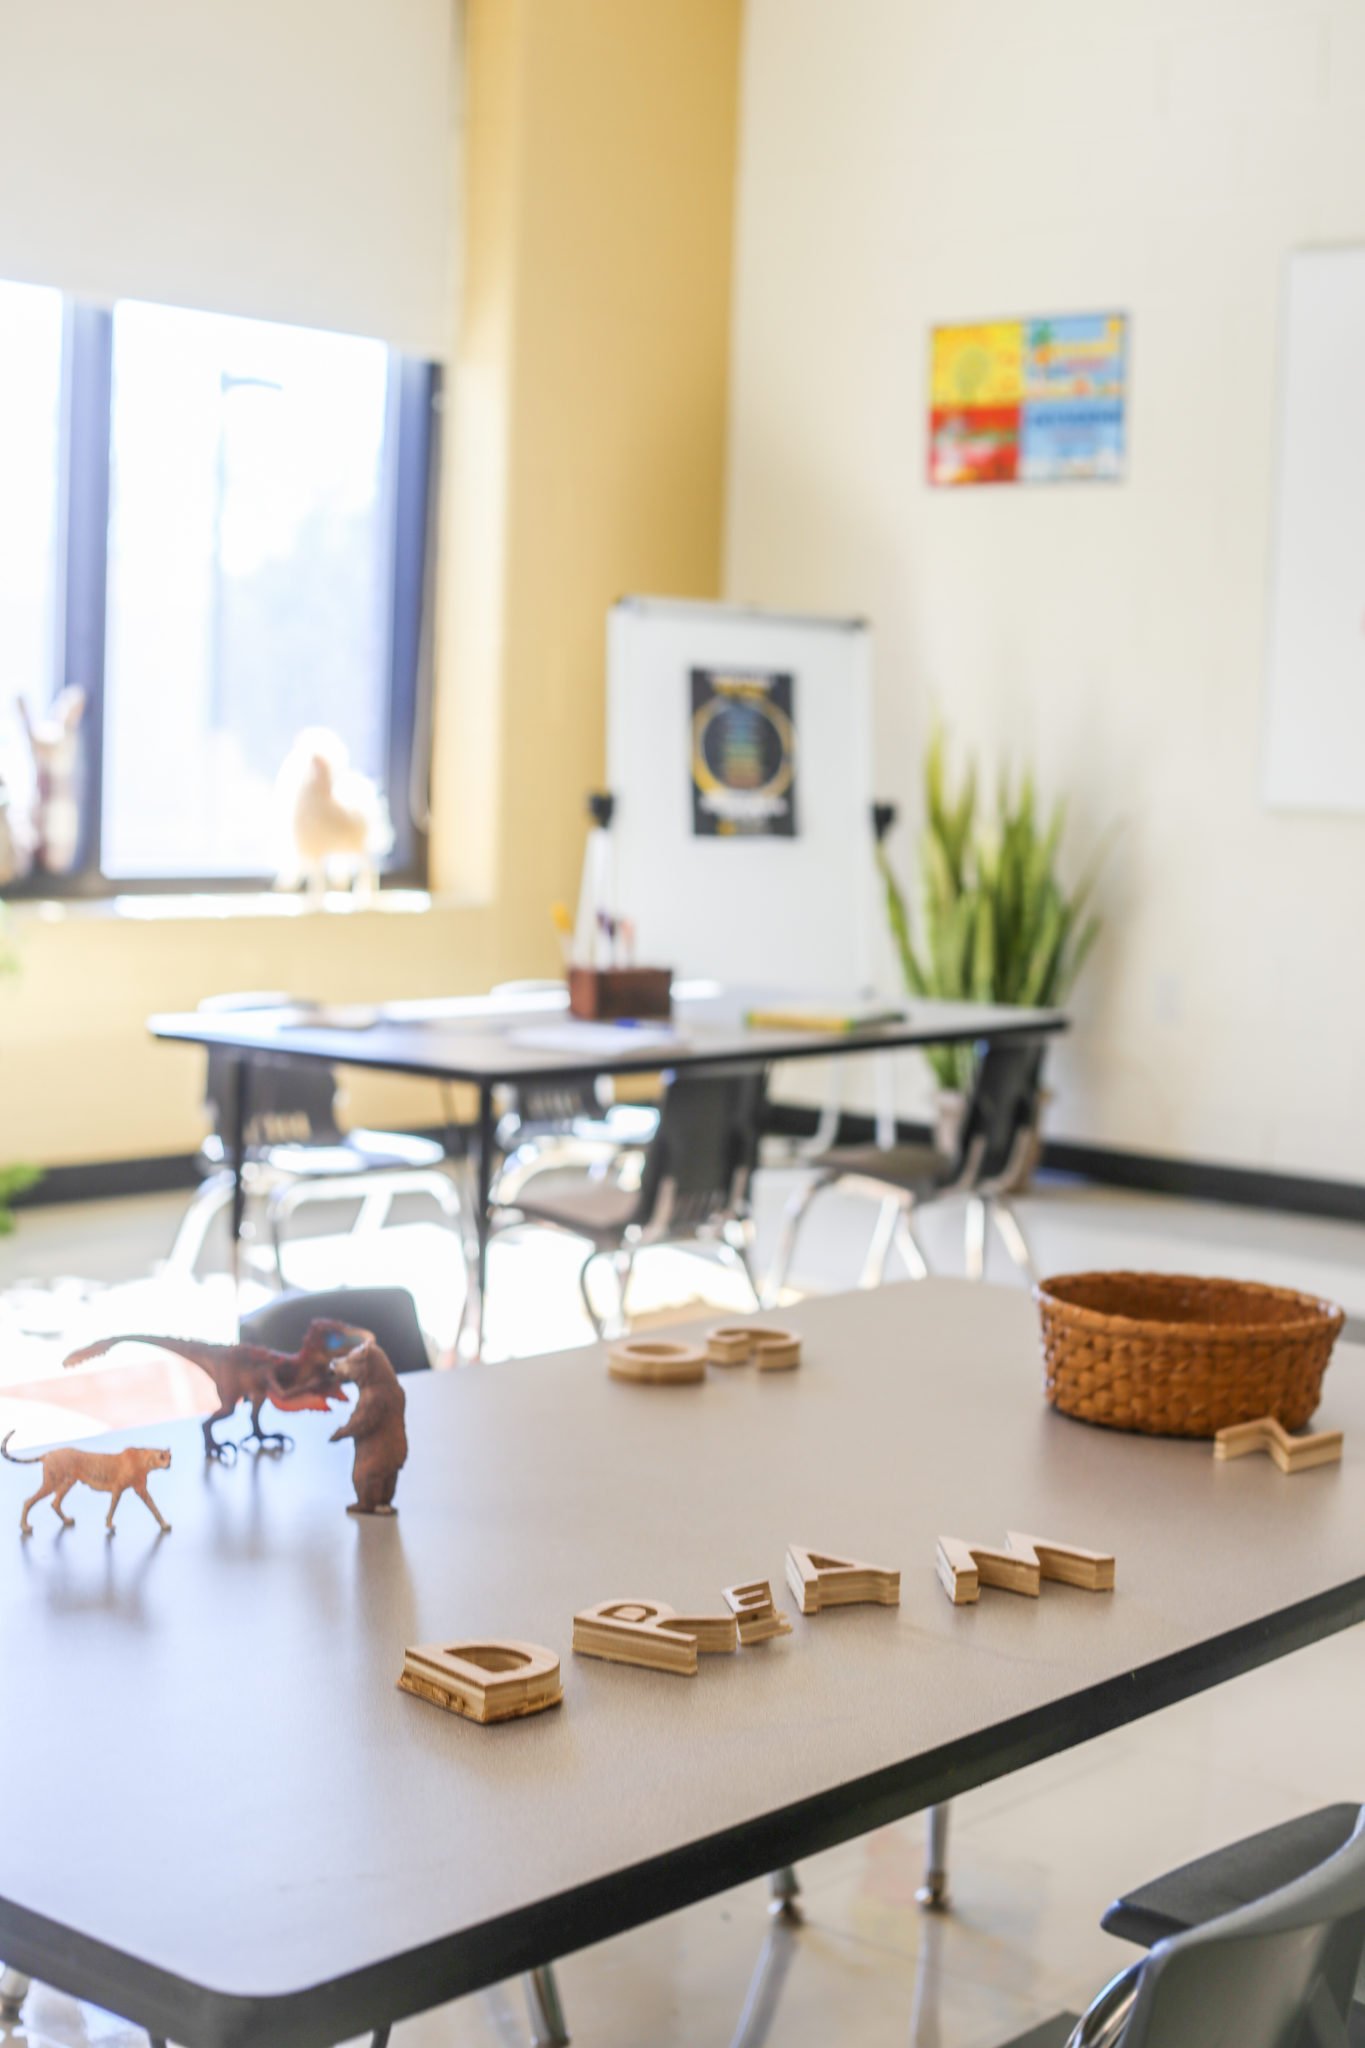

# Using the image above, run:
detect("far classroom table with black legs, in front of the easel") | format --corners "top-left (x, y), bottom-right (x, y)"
top-left (149, 983), bottom-right (1068, 1358)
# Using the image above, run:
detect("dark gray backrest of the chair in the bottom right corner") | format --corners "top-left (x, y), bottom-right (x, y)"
top-left (1124, 1815), bottom-right (1365, 2048)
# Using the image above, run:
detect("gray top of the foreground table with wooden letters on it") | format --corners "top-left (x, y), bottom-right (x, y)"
top-left (0, 1280), bottom-right (1365, 2048)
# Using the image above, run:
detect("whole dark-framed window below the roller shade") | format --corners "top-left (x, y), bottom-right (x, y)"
top-left (0, 285), bottom-right (436, 893)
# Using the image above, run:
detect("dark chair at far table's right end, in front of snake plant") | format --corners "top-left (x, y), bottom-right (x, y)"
top-left (767, 1038), bottom-right (1044, 1305)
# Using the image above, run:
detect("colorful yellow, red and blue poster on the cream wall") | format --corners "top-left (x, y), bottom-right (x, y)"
top-left (929, 313), bottom-right (1128, 483)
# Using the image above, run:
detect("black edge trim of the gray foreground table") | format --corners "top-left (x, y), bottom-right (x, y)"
top-left (0, 1577), bottom-right (1365, 2048)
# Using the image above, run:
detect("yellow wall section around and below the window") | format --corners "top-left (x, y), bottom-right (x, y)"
top-left (0, 0), bottom-right (741, 1165)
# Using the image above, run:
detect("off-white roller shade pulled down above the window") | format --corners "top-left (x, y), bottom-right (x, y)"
top-left (0, 0), bottom-right (456, 356)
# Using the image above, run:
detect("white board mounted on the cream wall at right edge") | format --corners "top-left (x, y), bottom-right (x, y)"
top-left (1265, 248), bottom-right (1365, 811)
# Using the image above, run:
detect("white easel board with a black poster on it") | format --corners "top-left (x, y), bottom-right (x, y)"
top-left (608, 598), bottom-right (876, 995)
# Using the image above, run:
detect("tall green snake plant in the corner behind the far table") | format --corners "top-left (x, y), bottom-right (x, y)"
top-left (876, 727), bottom-right (1105, 1153)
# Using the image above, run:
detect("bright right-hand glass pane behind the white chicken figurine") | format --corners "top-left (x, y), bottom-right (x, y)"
top-left (103, 297), bottom-right (393, 877)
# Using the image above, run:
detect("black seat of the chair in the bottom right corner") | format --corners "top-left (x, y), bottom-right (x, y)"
top-left (1101, 1804), bottom-right (1361, 1948)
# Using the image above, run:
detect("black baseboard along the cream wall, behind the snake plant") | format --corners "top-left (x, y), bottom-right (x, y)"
top-left (767, 1102), bottom-right (1365, 1223)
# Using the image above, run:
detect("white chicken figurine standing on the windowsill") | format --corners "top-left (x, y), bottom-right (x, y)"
top-left (276, 725), bottom-right (393, 895)
